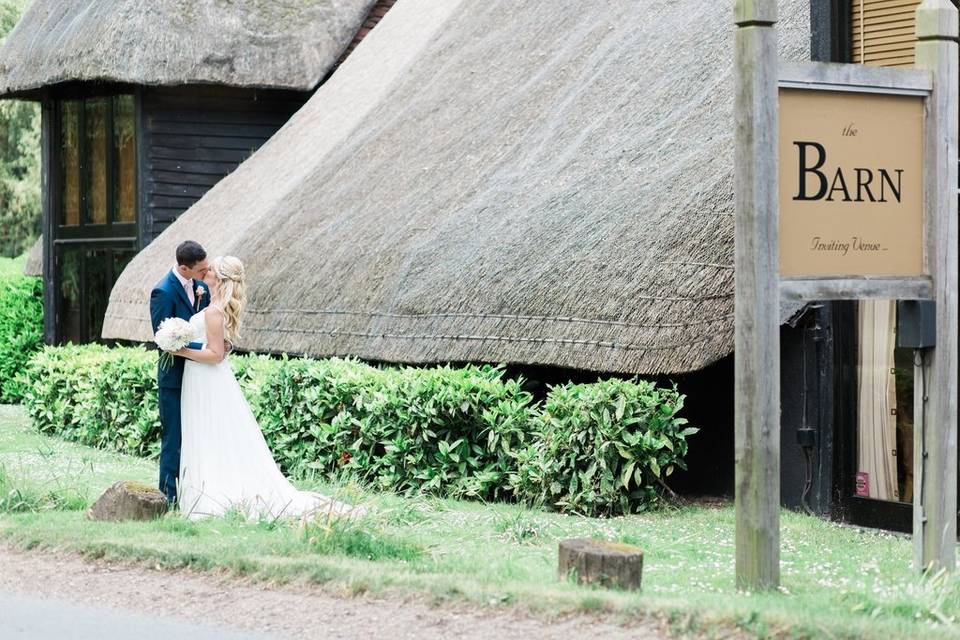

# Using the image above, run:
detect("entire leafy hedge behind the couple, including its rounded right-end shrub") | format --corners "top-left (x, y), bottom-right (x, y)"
top-left (25, 345), bottom-right (695, 515)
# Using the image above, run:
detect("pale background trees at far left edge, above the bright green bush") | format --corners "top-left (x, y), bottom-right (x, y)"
top-left (0, 0), bottom-right (40, 257)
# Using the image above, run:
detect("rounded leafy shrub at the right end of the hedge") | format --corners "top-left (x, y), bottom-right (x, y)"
top-left (512, 380), bottom-right (697, 516)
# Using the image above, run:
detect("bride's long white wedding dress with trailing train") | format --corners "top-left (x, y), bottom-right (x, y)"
top-left (179, 311), bottom-right (363, 519)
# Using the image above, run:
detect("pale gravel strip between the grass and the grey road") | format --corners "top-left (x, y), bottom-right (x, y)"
top-left (0, 546), bottom-right (667, 640)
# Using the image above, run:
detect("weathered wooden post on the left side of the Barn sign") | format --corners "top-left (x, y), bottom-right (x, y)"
top-left (734, 0), bottom-right (780, 590)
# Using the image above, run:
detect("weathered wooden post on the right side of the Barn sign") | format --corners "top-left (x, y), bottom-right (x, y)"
top-left (913, 0), bottom-right (958, 571)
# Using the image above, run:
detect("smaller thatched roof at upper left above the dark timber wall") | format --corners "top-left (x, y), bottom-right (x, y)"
top-left (0, 0), bottom-right (374, 96)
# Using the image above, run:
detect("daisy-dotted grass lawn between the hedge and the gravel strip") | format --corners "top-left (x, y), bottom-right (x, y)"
top-left (0, 406), bottom-right (960, 640)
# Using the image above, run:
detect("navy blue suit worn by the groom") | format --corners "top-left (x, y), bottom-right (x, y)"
top-left (150, 269), bottom-right (210, 504)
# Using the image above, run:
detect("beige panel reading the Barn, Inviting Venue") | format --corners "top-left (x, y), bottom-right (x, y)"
top-left (780, 89), bottom-right (923, 278)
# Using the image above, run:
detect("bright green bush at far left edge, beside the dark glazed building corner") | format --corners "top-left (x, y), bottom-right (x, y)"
top-left (0, 276), bottom-right (43, 403)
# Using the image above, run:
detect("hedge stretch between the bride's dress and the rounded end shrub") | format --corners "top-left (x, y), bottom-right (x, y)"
top-left (253, 359), bottom-right (531, 499)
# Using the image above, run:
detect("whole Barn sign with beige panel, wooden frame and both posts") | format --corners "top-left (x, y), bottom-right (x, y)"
top-left (734, 0), bottom-right (958, 589)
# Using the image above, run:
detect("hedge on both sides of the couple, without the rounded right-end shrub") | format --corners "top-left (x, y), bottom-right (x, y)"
top-left (25, 345), bottom-right (530, 498)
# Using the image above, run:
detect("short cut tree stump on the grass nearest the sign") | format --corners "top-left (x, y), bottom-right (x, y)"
top-left (558, 538), bottom-right (643, 589)
